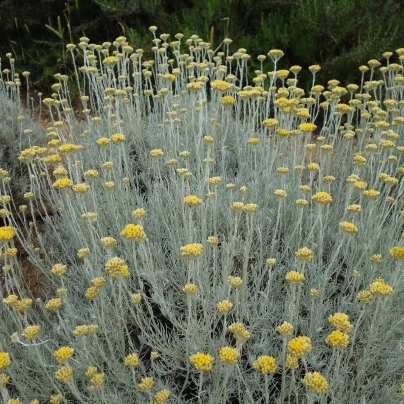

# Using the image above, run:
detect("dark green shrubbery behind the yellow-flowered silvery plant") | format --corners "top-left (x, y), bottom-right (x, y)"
top-left (0, 0), bottom-right (404, 90)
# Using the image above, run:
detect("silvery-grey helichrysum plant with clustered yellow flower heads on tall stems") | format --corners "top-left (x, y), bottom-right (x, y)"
top-left (0, 30), bottom-right (404, 404)
